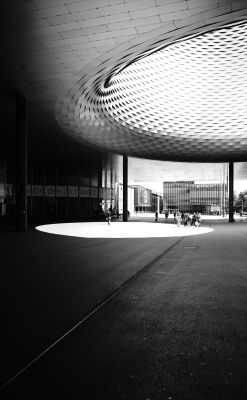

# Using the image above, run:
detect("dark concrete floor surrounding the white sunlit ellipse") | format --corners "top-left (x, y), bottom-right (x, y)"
top-left (0, 219), bottom-right (247, 400)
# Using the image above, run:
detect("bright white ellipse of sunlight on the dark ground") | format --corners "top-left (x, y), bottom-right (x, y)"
top-left (36, 221), bottom-right (213, 238)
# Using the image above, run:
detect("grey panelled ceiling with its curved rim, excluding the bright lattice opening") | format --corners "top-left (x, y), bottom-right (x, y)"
top-left (0, 0), bottom-right (247, 161)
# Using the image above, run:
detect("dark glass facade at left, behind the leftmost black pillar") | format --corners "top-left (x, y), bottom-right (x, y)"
top-left (0, 152), bottom-right (122, 222)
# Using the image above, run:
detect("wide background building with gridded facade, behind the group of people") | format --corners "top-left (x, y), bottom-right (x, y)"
top-left (163, 181), bottom-right (228, 215)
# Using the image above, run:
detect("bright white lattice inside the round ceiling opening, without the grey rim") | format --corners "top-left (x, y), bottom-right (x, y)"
top-left (102, 22), bottom-right (247, 142)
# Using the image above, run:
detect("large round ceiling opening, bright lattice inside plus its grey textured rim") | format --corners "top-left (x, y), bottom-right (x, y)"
top-left (57, 10), bottom-right (247, 161)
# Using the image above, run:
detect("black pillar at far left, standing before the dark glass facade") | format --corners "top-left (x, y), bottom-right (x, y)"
top-left (16, 97), bottom-right (27, 232)
